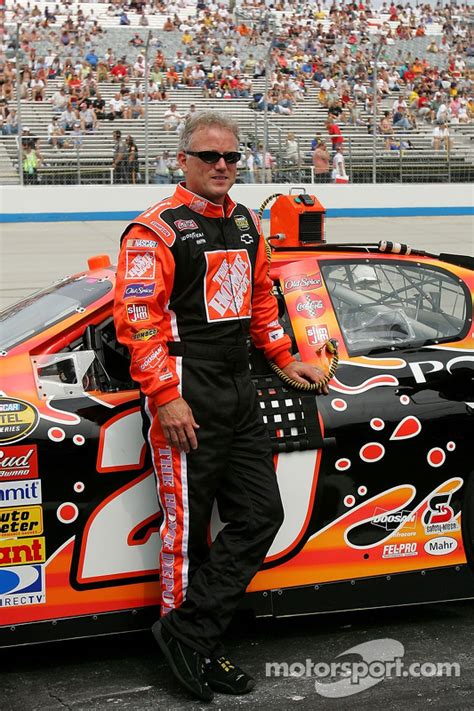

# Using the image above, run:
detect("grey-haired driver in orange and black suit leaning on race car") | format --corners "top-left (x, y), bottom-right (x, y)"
top-left (114, 112), bottom-right (323, 701)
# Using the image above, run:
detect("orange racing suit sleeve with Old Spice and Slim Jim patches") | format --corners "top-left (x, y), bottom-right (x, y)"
top-left (114, 225), bottom-right (180, 405)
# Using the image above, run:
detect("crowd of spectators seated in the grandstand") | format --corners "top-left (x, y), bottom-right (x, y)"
top-left (0, 0), bottom-right (474, 180)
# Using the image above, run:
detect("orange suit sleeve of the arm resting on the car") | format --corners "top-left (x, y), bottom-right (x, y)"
top-left (250, 229), bottom-right (295, 368)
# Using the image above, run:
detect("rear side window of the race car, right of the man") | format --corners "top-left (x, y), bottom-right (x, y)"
top-left (321, 259), bottom-right (468, 355)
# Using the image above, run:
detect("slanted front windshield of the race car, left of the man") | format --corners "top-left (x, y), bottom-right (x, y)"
top-left (0, 276), bottom-right (112, 351)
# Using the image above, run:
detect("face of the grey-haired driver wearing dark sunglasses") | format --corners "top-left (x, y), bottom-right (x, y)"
top-left (177, 126), bottom-right (238, 205)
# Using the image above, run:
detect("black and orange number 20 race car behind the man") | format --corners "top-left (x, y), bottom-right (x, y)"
top-left (0, 195), bottom-right (474, 646)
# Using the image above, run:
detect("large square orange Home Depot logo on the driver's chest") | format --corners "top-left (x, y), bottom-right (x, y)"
top-left (204, 249), bottom-right (251, 323)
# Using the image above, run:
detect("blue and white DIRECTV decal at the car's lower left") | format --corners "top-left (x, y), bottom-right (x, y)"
top-left (0, 565), bottom-right (46, 607)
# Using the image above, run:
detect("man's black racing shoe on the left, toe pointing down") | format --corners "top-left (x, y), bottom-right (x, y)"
top-left (151, 622), bottom-right (214, 701)
